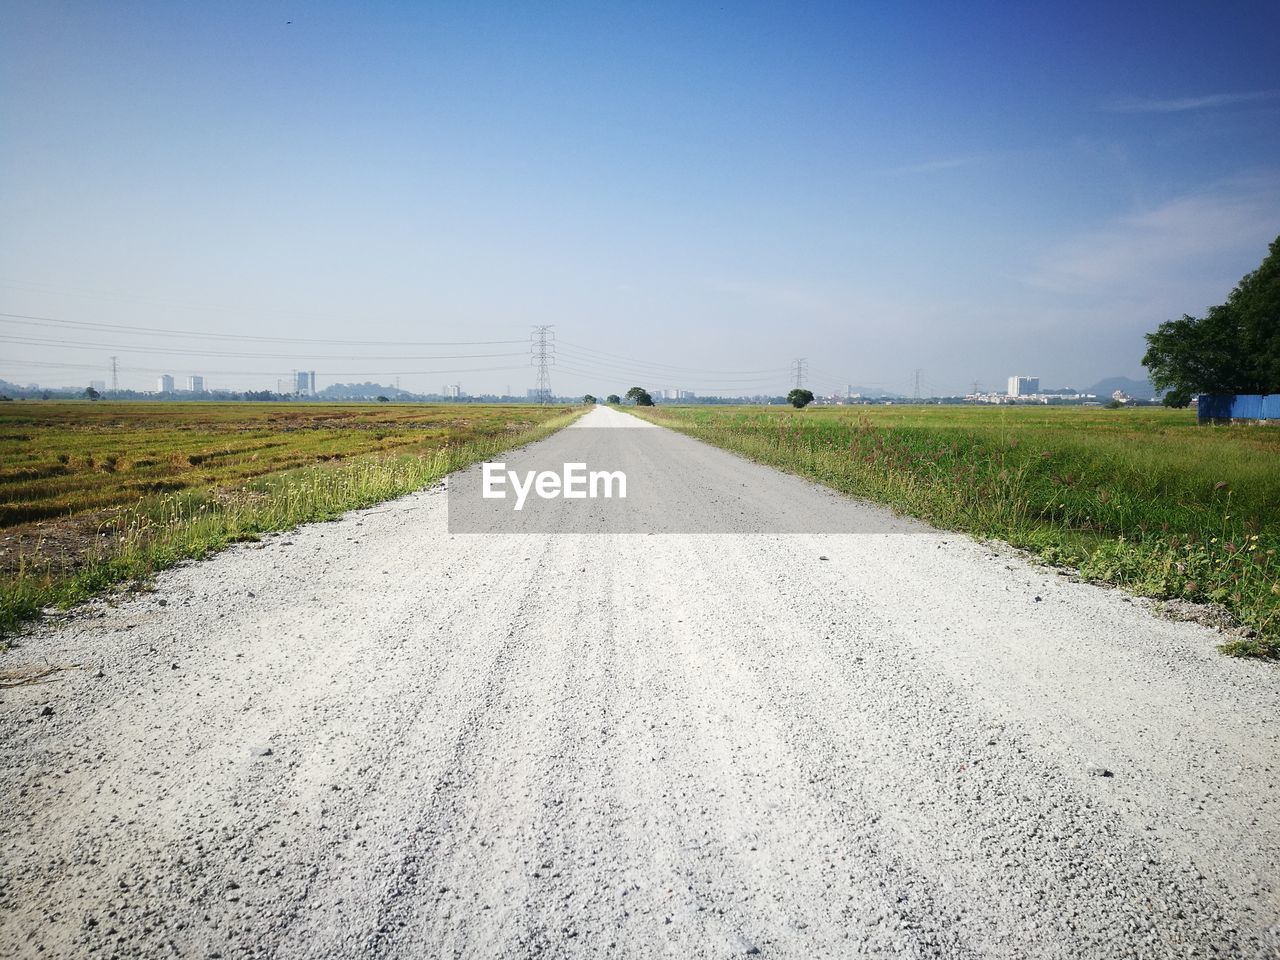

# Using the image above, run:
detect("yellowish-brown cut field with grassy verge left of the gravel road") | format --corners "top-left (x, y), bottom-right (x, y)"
top-left (0, 402), bottom-right (582, 643)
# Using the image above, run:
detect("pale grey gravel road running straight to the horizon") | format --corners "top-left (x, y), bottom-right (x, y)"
top-left (0, 408), bottom-right (1280, 957)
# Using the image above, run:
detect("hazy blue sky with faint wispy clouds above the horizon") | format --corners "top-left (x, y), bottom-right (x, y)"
top-left (0, 0), bottom-right (1280, 393)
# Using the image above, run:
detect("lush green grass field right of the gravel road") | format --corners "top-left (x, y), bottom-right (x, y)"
top-left (632, 406), bottom-right (1280, 657)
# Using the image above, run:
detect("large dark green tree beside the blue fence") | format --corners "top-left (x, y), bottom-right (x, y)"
top-left (1142, 237), bottom-right (1280, 406)
